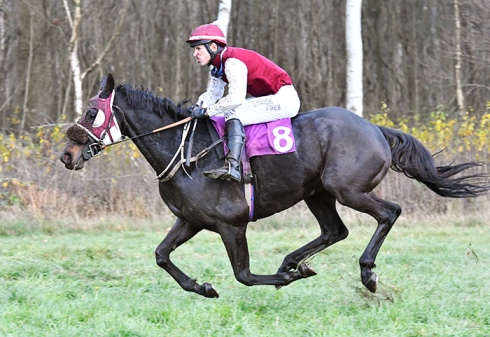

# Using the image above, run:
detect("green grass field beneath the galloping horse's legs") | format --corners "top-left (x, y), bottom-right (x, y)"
top-left (0, 213), bottom-right (490, 337)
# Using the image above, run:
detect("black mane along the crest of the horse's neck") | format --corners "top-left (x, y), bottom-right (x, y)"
top-left (116, 83), bottom-right (189, 119)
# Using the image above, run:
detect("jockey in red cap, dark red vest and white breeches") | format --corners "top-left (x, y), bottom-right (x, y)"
top-left (186, 24), bottom-right (300, 181)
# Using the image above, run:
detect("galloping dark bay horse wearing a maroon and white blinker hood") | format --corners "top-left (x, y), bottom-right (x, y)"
top-left (60, 74), bottom-right (490, 297)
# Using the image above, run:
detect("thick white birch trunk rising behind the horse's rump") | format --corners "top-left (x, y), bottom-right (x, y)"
top-left (345, 0), bottom-right (363, 117)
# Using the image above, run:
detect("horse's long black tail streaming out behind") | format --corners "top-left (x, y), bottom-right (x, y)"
top-left (377, 125), bottom-right (490, 198)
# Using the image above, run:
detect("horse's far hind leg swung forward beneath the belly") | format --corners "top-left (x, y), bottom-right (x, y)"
top-left (277, 190), bottom-right (349, 275)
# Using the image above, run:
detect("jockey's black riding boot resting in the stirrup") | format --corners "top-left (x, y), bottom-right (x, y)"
top-left (204, 118), bottom-right (245, 181)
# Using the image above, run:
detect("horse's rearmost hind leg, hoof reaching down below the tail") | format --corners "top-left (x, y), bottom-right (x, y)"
top-left (339, 192), bottom-right (401, 293)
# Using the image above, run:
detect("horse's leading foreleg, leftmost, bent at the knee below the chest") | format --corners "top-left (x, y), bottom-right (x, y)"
top-left (155, 219), bottom-right (219, 297)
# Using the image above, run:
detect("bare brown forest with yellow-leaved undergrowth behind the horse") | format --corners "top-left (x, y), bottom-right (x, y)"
top-left (0, 0), bottom-right (490, 223)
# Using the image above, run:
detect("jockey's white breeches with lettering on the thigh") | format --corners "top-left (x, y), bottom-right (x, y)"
top-left (219, 85), bottom-right (300, 125)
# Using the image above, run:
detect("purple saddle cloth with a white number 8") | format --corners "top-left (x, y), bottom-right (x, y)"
top-left (211, 116), bottom-right (296, 160)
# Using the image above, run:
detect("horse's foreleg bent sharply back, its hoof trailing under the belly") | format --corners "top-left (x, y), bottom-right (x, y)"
top-left (219, 225), bottom-right (311, 286)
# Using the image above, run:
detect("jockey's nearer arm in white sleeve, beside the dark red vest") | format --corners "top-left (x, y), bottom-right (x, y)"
top-left (206, 58), bottom-right (248, 117)
